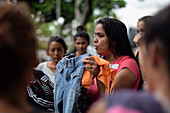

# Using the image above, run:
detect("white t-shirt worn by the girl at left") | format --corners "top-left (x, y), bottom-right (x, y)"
top-left (36, 62), bottom-right (55, 84)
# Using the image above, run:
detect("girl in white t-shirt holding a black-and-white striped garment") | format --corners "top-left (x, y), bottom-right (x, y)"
top-left (27, 36), bottom-right (67, 112)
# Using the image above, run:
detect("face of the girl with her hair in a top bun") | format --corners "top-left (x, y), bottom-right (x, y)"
top-left (75, 37), bottom-right (88, 55)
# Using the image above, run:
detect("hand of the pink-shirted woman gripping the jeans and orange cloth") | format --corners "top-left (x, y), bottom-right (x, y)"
top-left (82, 57), bottom-right (100, 77)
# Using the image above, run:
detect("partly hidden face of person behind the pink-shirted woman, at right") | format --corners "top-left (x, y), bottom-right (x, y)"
top-left (137, 20), bottom-right (145, 37)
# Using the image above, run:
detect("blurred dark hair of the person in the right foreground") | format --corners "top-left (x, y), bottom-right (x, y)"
top-left (144, 5), bottom-right (170, 73)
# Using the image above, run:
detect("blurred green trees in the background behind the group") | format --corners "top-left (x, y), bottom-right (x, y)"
top-left (17, 0), bottom-right (126, 52)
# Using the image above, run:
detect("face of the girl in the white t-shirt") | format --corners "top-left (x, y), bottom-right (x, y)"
top-left (48, 41), bottom-right (64, 64)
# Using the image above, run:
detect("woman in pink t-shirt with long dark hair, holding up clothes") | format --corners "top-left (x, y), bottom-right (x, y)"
top-left (82, 17), bottom-right (140, 101)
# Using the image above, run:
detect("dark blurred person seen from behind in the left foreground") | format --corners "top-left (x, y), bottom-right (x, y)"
top-left (0, 3), bottom-right (38, 113)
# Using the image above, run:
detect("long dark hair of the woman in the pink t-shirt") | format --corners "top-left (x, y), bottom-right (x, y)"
top-left (96, 17), bottom-right (135, 59)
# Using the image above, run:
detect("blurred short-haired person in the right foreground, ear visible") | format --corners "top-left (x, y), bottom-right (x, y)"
top-left (139, 5), bottom-right (170, 113)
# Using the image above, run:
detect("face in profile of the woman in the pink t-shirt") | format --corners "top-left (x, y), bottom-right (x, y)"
top-left (93, 24), bottom-right (111, 57)
